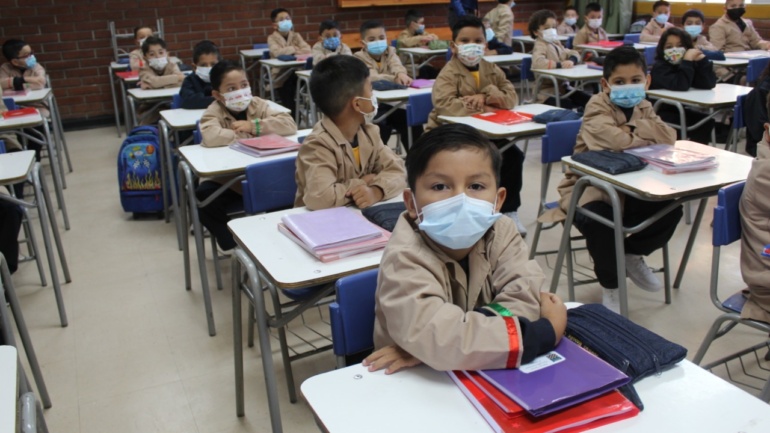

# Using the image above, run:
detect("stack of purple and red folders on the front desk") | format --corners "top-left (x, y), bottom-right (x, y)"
top-left (449, 338), bottom-right (639, 433)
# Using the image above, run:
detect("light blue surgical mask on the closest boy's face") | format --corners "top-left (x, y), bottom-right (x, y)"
top-left (412, 193), bottom-right (502, 250)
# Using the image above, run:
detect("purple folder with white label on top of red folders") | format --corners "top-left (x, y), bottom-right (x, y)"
top-left (479, 338), bottom-right (631, 416)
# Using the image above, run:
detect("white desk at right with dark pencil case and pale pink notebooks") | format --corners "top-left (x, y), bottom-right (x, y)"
top-left (551, 141), bottom-right (752, 317)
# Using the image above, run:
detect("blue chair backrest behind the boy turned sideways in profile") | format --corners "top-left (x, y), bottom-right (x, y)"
top-left (241, 157), bottom-right (297, 215)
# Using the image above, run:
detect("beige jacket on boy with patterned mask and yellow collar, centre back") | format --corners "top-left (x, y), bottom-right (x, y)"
top-left (425, 56), bottom-right (519, 131)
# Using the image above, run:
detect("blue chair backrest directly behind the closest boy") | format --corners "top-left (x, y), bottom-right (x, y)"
top-left (329, 269), bottom-right (379, 356)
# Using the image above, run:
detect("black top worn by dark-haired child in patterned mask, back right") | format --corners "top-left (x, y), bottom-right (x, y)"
top-left (650, 58), bottom-right (717, 92)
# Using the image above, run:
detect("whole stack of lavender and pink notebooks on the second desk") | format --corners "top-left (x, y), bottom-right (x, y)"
top-left (278, 207), bottom-right (390, 263)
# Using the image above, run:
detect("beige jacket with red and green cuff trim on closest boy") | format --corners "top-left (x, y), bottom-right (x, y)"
top-left (374, 213), bottom-right (545, 370)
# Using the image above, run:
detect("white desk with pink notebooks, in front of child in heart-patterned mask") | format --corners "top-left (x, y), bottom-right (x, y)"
top-left (177, 129), bottom-right (311, 336)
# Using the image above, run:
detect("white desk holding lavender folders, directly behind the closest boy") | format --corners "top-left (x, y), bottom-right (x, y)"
top-left (228, 199), bottom-right (398, 433)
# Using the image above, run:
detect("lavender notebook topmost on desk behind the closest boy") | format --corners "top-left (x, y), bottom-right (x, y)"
top-left (281, 207), bottom-right (382, 250)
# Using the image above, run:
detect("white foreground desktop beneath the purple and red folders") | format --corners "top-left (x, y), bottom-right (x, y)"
top-left (302, 360), bottom-right (770, 433)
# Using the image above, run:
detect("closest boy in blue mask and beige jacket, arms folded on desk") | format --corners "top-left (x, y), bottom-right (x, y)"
top-left (363, 123), bottom-right (567, 373)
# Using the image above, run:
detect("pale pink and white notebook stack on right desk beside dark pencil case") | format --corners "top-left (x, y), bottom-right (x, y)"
top-left (625, 144), bottom-right (719, 174)
